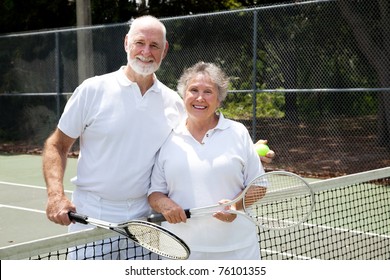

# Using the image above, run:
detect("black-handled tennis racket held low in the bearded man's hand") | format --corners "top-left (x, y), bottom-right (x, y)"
top-left (69, 212), bottom-right (190, 260)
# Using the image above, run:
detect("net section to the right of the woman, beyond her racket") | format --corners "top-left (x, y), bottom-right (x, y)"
top-left (259, 167), bottom-right (390, 260)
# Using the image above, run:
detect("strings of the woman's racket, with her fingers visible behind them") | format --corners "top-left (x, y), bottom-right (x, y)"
top-left (243, 174), bottom-right (313, 229)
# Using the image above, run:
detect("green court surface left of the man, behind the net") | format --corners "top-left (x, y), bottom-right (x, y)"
top-left (0, 155), bottom-right (77, 247)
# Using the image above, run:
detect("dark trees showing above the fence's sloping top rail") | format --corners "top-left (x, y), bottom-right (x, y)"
top-left (0, 0), bottom-right (280, 34)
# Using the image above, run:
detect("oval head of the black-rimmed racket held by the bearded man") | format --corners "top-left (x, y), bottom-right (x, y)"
top-left (123, 220), bottom-right (191, 260)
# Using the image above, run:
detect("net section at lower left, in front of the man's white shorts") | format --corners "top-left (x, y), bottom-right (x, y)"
top-left (0, 228), bottom-right (160, 260)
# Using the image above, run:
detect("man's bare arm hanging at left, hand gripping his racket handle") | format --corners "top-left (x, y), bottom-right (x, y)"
top-left (42, 128), bottom-right (76, 225)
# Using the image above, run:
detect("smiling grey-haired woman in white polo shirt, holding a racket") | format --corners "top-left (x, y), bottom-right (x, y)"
top-left (148, 62), bottom-right (264, 260)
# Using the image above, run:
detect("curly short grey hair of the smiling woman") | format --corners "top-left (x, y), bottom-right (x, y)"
top-left (177, 61), bottom-right (229, 103)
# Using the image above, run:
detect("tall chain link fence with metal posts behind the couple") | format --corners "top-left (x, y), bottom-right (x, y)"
top-left (0, 0), bottom-right (390, 177)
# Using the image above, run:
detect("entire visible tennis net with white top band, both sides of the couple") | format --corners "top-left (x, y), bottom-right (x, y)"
top-left (0, 167), bottom-right (390, 260)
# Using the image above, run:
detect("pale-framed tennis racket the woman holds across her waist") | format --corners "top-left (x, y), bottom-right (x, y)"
top-left (148, 171), bottom-right (315, 230)
